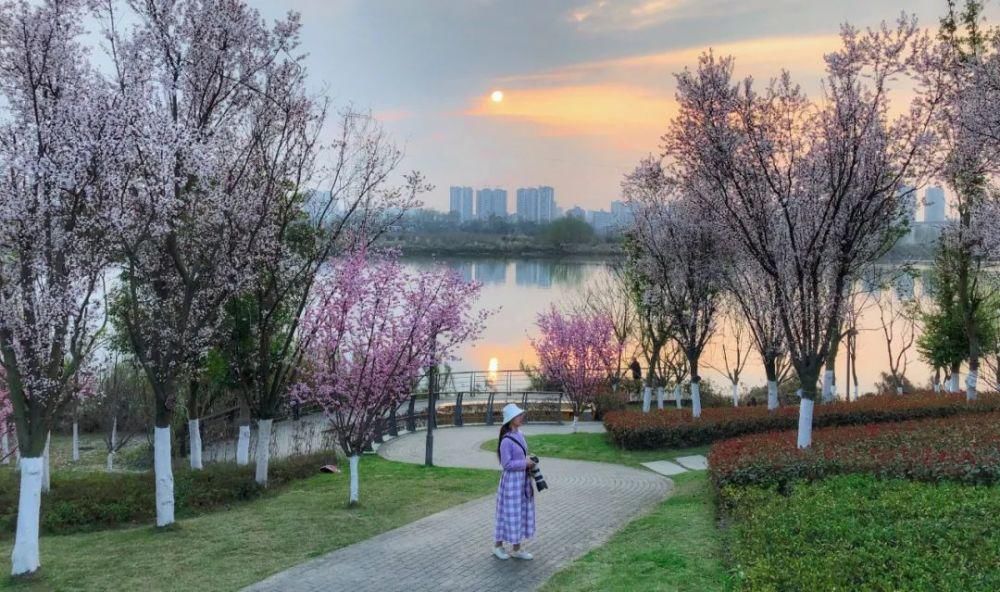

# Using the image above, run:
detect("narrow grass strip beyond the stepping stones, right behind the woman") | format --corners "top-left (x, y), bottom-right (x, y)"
top-left (483, 433), bottom-right (709, 467)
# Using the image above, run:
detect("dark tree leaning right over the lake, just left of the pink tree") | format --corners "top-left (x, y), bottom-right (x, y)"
top-left (221, 109), bottom-right (430, 485)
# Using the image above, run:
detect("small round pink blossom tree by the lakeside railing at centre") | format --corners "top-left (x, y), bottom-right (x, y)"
top-left (531, 307), bottom-right (622, 433)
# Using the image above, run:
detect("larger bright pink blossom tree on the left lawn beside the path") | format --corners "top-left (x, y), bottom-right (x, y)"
top-left (292, 251), bottom-right (486, 504)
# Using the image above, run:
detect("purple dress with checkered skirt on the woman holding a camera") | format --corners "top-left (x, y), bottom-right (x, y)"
top-left (493, 431), bottom-right (535, 545)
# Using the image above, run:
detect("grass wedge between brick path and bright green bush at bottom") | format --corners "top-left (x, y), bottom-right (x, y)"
top-left (542, 472), bottom-right (729, 592)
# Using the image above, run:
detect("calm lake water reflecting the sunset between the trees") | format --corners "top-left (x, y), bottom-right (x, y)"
top-left (406, 257), bottom-right (932, 393)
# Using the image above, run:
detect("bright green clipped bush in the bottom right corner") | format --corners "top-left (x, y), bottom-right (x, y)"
top-left (729, 475), bottom-right (1000, 591)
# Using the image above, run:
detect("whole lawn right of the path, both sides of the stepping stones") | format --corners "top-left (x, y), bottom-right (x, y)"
top-left (483, 433), bottom-right (730, 592)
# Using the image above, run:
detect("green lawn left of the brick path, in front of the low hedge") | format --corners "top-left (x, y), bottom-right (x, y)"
top-left (0, 456), bottom-right (497, 592)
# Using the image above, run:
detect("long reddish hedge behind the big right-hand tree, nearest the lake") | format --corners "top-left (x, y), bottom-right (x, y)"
top-left (604, 393), bottom-right (1000, 450)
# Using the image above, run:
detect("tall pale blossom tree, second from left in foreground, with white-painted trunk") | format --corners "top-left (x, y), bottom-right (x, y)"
top-left (100, 0), bottom-right (318, 526)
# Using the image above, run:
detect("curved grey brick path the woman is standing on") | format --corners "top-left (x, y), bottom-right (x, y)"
top-left (247, 424), bottom-right (673, 592)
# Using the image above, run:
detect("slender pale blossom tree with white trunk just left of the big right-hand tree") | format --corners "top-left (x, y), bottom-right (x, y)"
top-left (623, 159), bottom-right (729, 417)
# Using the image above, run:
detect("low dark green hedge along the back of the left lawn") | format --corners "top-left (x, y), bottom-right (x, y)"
top-left (0, 452), bottom-right (335, 534)
